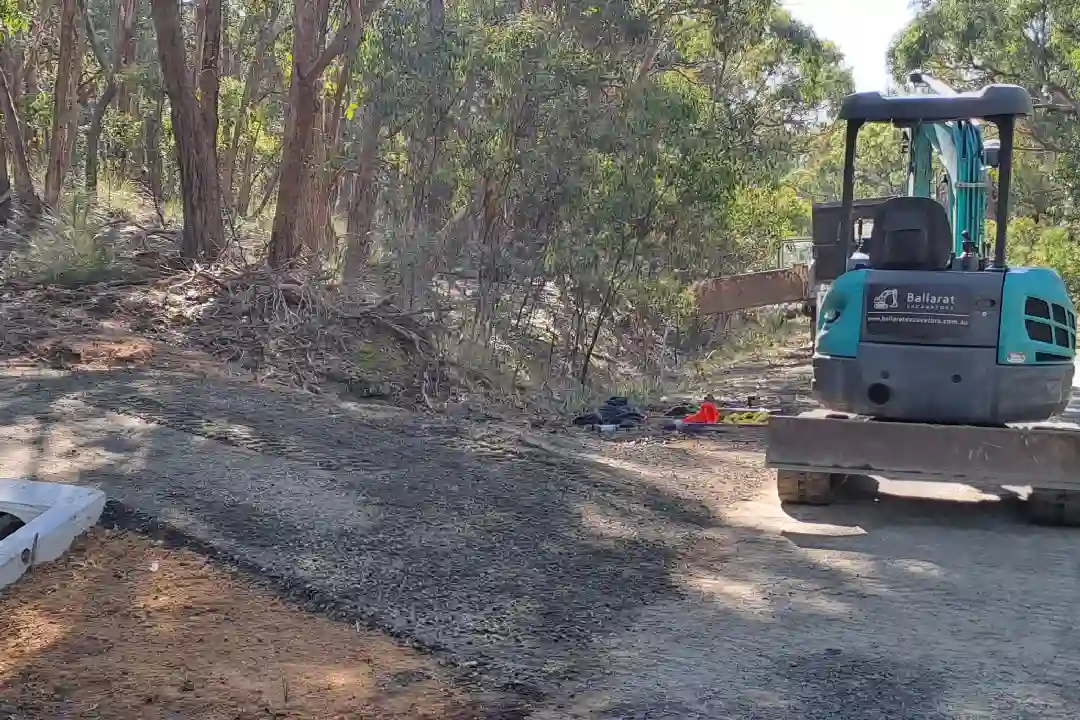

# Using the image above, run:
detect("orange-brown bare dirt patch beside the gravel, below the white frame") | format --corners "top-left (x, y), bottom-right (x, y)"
top-left (0, 528), bottom-right (494, 720)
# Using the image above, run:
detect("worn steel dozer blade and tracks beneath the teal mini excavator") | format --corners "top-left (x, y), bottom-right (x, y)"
top-left (766, 410), bottom-right (1080, 527)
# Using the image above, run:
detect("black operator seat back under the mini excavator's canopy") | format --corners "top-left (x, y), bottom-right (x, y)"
top-left (867, 198), bottom-right (953, 270)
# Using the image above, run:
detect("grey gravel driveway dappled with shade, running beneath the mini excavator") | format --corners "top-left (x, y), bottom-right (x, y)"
top-left (0, 362), bottom-right (1080, 720)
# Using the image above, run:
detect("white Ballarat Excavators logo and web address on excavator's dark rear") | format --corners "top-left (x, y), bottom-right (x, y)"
top-left (866, 285), bottom-right (971, 337)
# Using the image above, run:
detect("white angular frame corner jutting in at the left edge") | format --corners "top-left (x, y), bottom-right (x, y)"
top-left (0, 479), bottom-right (105, 588)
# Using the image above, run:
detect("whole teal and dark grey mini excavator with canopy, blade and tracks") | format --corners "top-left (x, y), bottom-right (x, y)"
top-left (766, 73), bottom-right (1080, 525)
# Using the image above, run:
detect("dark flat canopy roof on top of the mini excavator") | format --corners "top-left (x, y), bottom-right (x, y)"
top-left (840, 84), bottom-right (1031, 124)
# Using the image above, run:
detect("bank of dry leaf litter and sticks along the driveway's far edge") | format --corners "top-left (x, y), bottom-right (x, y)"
top-left (0, 260), bottom-right (809, 424)
